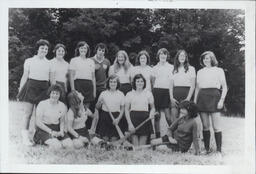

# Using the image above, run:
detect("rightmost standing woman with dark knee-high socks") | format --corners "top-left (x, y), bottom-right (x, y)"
top-left (194, 51), bottom-right (227, 154)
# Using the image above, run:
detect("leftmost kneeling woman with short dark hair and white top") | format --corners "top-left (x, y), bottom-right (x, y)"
top-left (33, 85), bottom-right (70, 148)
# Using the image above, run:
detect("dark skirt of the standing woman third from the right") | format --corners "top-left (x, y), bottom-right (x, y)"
top-left (152, 88), bottom-right (170, 110)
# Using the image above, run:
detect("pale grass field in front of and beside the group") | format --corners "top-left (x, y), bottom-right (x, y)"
top-left (9, 101), bottom-right (244, 165)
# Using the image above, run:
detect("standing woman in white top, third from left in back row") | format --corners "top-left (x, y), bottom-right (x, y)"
top-left (69, 41), bottom-right (96, 108)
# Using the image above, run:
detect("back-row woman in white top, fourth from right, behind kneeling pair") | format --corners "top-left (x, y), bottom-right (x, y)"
top-left (131, 50), bottom-right (153, 91)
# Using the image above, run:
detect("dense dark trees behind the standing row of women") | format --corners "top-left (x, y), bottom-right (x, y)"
top-left (9, 9), bottom-right (245, 115)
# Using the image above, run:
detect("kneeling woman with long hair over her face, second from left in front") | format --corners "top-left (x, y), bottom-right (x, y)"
top-left (67, 91), bottom-right (92, 148)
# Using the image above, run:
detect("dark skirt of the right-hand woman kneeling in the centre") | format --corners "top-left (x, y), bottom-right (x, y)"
top-left (130, 111), bottom-right (153, 136)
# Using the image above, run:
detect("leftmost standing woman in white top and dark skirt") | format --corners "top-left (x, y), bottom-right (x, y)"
top-left (17, 39), bottom-right (50, 145)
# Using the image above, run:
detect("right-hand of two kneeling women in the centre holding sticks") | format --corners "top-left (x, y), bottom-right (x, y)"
top-left (125, 74), bottom-right (155, 146)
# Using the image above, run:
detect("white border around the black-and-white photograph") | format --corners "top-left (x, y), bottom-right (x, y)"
top-left (0, 0), bottom-right (256, 174)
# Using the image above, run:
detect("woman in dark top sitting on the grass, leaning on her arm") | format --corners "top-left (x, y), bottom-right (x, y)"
top-left (151, 101), bottom-right (200, 155)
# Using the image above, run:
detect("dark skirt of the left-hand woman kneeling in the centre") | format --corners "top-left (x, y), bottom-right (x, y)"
top-left (97, 110), bottom-right (119, 138)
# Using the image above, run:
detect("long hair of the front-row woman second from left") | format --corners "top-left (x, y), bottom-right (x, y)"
top-left (67, 91), bottom-right (81, 118)
